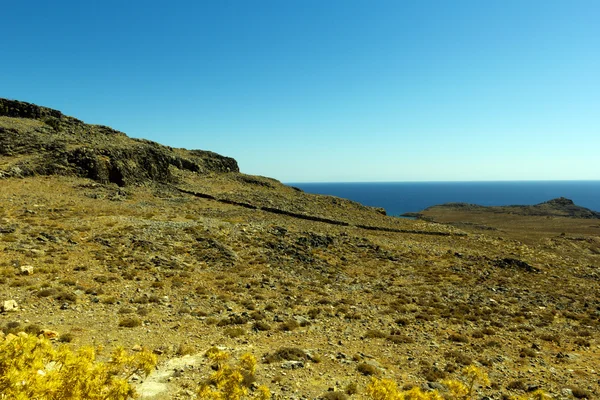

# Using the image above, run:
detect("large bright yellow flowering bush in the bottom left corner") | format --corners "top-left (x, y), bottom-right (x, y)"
top-left (0, 332), bottom-right (157, 400)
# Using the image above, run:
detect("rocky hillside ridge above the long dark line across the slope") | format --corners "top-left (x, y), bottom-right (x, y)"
top-left (0, 98), bottom-right (450, 235)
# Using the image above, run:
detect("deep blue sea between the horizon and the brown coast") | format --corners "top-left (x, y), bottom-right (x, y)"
top-left (288, 181), bottom-right (600, 216)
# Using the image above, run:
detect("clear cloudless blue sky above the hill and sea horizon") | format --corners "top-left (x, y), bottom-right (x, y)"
top-left (0, 0), bottom-right (600, 182)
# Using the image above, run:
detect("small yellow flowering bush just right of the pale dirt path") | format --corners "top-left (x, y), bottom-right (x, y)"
top-left (198, 349), bottom-right (271, 400)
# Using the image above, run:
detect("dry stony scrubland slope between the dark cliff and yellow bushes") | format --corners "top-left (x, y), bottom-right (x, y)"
top-left (0, 99), bottom-right (600, 399)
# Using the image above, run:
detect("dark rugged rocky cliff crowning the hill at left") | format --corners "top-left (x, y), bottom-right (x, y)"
top-left (0, 98), bottom-right (239, 186)
